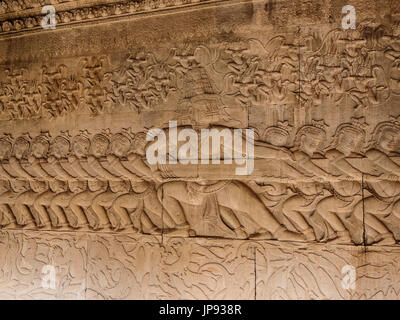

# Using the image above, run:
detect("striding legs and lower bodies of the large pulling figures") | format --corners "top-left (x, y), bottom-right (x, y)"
top-left (0, 172), bottom-right (400, 245)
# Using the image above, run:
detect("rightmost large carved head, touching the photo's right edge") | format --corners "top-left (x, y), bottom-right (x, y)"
top-left (367, 117), bottom-right (400, 154)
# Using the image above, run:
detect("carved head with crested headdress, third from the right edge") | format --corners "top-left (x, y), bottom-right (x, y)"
top-left (294, 120), bottom-right (326, 157)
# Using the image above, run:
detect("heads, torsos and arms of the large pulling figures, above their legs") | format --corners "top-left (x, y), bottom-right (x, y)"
top-left (0, 117), bottom-right (400, 172)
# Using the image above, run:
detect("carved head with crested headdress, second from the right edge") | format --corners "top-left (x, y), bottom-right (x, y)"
top-left (328, 118), bottom-right (368, 156)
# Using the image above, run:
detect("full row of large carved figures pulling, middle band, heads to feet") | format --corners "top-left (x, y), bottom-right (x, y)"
top-left (0, 118), bottom-right (400, 244)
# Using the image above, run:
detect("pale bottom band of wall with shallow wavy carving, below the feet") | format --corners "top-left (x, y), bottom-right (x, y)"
top-left (0, 231), bottom-right (400, 300)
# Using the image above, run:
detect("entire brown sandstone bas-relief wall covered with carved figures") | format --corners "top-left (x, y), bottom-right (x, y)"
top-left (0, 0), bottom-right (400, 299)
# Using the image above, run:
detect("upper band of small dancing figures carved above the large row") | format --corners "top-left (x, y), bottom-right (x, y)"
top-left (0, 24), bottom-right (400, 120)
